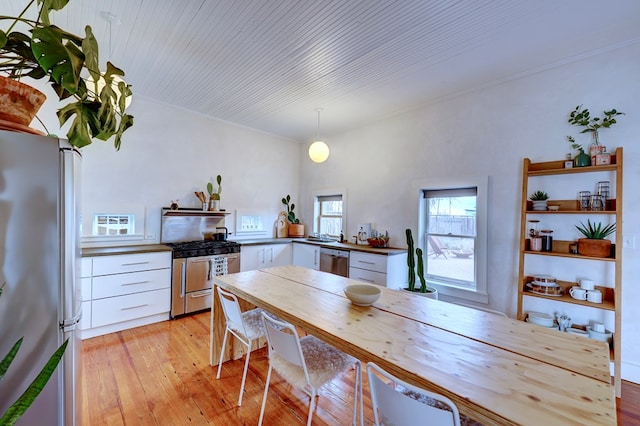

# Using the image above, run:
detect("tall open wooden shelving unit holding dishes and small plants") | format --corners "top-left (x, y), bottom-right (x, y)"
top-left (518, 148), bottom-right (622, 396)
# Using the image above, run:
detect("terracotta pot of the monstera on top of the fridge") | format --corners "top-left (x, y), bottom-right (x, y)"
top-left (0, 76), bottom-right (47, 126)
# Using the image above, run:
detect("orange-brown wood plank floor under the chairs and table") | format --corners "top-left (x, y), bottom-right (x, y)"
top-left (82, 312), bottom-right (640, 426)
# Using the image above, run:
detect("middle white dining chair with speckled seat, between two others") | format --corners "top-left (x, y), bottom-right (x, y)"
top-left (258, 313), bottom-right (364, 426)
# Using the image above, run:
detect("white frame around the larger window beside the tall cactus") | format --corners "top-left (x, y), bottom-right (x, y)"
top-left (415, 176), bottom-right (489, 303)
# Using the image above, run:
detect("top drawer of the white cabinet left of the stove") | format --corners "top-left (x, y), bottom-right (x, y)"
top-left (93, 252), bottom-right (171, 277)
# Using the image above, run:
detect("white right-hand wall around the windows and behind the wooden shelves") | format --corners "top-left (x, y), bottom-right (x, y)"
top-left (300, 45), bottom-right (640, 382)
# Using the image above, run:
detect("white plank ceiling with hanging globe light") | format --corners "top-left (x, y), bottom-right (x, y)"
top-left (5, 0), bottom-right (640, 142)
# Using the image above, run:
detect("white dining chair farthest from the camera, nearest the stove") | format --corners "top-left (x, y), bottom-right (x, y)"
top-left (216, 287), bottom-right (265, 406)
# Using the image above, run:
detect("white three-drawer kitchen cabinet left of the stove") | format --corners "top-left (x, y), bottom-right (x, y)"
top-left (81, 251), bottom-right (171, 339)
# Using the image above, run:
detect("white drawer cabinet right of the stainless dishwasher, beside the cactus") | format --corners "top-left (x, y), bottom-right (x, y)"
top-left (349, 251), bottom-right (407, 289)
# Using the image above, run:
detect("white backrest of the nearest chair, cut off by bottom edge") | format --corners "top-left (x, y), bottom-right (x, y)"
top-left (367, 362), bottom-right (460, 426)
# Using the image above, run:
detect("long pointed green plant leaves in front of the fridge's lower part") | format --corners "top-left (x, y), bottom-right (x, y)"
top-left (0, 284), bottom-right (69, 425)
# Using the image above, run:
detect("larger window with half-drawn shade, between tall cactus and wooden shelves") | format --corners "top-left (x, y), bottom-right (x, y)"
top-left (417, 178), bottom-right (488, 302)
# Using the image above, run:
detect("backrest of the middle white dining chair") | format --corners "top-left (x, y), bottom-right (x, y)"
top-left (262, 312), bottom-right (309, 374)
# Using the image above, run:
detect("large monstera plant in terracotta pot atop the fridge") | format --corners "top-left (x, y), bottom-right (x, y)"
top-left (0, 0), bottom-right (133, 149)
